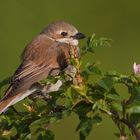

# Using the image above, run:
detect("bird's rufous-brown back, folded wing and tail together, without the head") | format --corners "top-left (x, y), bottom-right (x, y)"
top-left (0, 36), bottom-right (64, 113)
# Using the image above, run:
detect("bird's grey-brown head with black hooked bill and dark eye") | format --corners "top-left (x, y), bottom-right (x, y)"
top-left (42, 21), bottom-right (85, 46)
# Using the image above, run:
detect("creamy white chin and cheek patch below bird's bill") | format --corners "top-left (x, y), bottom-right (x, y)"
top-left (56, 38), bottom-right (79, 46)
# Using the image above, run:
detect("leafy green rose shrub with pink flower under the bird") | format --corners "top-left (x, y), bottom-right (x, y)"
top-left (0, 34), bottom-right (140, 140)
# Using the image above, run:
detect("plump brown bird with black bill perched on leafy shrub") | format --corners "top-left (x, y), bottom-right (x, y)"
top-left (0, 21), bottom-right (85, 114)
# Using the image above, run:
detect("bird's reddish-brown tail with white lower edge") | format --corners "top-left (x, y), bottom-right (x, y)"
top-left (0, 88), bottom-right (36, 114)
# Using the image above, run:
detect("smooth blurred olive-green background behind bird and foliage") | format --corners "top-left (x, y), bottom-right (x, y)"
top-left (0, 0), bottom-right (140, 140)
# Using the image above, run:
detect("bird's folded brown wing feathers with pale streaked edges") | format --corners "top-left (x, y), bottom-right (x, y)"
top-left (3, 61), bottom-right (51, 99)
